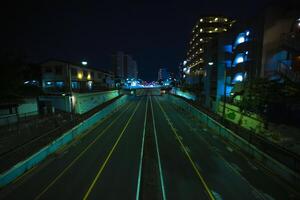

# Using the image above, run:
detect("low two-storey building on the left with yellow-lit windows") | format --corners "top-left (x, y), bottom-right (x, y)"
top-left (41, 60), bottom-right (114, 93)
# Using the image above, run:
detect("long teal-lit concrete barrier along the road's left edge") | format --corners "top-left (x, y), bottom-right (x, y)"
top-left (0, 95), bottom-right (130, 187)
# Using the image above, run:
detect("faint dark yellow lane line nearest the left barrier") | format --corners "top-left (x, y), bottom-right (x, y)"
top-left (34, 101), bottom-right (134, 200)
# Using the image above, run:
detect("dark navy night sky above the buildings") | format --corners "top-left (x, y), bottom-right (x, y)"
top-left (0, 0), bottom-right (271, 80)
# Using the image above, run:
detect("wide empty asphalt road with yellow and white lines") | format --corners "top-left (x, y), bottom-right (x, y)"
top-left (0, 93), bottom-right (296, 200)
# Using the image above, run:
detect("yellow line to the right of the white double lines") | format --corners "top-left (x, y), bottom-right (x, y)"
top-left (155, 98), bottom-right (215, 200)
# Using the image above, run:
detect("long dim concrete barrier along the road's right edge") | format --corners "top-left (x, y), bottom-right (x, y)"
top-left (167, 95), bottom-right (300, 188)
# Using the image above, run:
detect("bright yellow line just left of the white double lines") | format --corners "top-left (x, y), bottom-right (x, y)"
top-left (83, 96), bottom-right (142, 200)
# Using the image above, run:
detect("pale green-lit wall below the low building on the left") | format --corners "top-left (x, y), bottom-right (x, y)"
top-left (73, 90), bottom-right (119, 114)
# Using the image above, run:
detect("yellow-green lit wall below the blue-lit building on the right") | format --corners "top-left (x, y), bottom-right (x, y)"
top-left (217, 102), bottom-right (264, 133)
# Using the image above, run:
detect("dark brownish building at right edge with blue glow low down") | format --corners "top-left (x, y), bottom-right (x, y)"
top-left (261, 3), bottom-right (300, 82)
